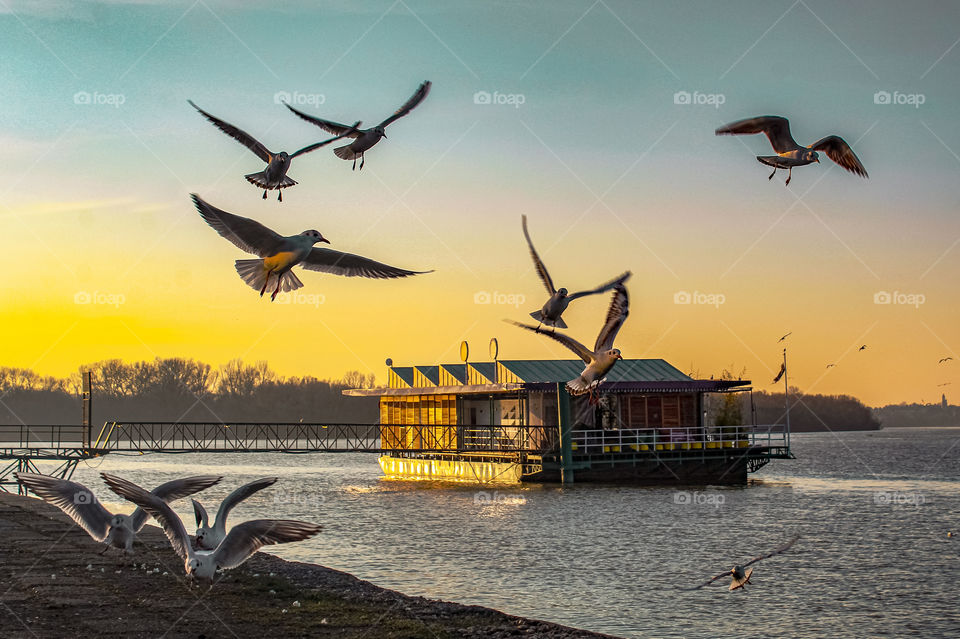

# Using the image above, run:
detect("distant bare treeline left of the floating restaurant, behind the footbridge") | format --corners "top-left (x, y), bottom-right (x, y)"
top-left (0, 358), bottom-right (378, 424)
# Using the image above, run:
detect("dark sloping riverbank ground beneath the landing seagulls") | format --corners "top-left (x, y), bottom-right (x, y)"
top-left (0, 492), bottom-right (609, 639)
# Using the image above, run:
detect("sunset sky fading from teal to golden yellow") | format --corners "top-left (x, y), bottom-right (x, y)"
top-left (0, 0), bottom-right (960, 405)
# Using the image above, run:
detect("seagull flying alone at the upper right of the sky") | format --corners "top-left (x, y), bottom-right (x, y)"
top-left (716, 115), bottom-right (869, 184)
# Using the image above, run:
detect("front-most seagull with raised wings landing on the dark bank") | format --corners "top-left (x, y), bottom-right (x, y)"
top-left (102, 473), bottom-right (321, 582)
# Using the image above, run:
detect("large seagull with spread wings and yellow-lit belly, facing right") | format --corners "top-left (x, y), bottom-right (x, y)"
top-left (190, 194), bottom-right (433, 300)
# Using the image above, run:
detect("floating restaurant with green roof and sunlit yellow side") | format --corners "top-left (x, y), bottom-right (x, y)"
top-left (344, 350), bottom-right (793, 484)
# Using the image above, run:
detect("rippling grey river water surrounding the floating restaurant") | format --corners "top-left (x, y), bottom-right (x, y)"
top-left (30, 429), bottom-right (960, 637)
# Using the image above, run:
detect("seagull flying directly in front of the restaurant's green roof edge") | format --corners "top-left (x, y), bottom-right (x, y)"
top-left (510, 284), bottom-right (630, 403)
